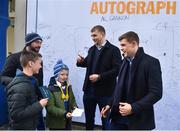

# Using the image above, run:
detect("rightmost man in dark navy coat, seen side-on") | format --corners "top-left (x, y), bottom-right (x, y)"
top-left (101, 31), bottom-right (162, 130)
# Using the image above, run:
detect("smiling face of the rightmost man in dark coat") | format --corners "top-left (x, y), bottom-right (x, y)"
top-left (120, 39), bottom-right (136, 58)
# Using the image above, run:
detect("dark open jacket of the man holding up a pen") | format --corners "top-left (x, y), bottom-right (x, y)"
top-left (77, 41), bottom-right (121, 96)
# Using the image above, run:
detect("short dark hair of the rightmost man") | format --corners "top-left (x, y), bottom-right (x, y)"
top-left (119, 31), bottom-right (139, 45)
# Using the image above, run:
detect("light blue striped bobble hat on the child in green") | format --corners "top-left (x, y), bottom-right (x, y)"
top-left (54, 59), bottom-right (69, 77)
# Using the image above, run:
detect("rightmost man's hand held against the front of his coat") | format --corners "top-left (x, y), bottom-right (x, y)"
top-left (119, 102), bottom-right (132, 116)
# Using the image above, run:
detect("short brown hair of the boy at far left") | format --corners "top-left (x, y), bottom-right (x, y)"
top-left (20, 50), bottom-right (42, 67)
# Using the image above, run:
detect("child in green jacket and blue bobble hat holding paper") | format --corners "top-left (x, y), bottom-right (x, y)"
top-left (46, 60), bottom-right (77, 130)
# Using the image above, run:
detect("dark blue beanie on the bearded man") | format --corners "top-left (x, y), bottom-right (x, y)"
top-left (25, 33), bottom-right (42, 46)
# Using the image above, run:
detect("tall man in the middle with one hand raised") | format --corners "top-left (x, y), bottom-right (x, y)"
top-left (77, 25), bottom-right (121, 130)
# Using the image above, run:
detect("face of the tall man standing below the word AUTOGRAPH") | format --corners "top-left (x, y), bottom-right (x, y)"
top-left (91, 30), bottom-right (105, 45)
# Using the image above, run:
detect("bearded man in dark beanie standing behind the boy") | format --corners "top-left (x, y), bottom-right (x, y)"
top-left (0, 33), bottom-right (45, 130)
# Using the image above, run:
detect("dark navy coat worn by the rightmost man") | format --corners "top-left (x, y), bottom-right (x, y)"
top-left (111, 47), bottom-right (162, 130)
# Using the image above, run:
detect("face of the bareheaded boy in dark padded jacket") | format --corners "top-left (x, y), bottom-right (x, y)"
top-left (30, 57), bottom-right (42, 74)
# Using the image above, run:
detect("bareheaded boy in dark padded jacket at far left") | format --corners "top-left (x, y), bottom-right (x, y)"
top-left (7, 50), bottom-right (48, 130)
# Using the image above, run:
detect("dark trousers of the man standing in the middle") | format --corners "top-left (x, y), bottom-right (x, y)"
top-left (83, 93), bottom-right (110, 130)
